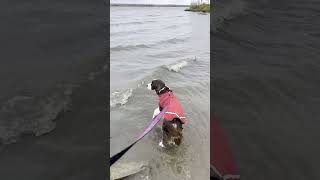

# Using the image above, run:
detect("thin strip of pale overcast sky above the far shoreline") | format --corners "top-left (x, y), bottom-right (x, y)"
top-left (110, 0), bottom-right (207, 5)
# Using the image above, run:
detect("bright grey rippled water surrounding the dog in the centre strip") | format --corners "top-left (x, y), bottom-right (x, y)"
top-left (110, 7), bottom-right (210, 179)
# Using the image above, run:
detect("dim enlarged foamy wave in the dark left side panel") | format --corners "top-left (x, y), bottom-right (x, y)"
top-left (0, 86), bottom-right (72, 145)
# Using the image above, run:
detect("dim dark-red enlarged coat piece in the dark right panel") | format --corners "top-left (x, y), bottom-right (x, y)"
top-left (210, 114), bottom-right (240, 180)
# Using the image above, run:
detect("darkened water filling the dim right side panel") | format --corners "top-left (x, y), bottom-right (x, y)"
top-left (211, 0), bottom-right (320, 180)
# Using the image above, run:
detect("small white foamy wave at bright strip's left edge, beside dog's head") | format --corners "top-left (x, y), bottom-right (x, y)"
top-left (110, 88), bottom-right (133, 107)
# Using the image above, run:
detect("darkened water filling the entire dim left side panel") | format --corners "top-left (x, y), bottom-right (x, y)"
top-left (0, 0), bottom-right (108, 180)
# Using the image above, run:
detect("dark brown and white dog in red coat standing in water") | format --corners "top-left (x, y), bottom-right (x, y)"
top-left (147, 79), bottom-right (186, 147)
